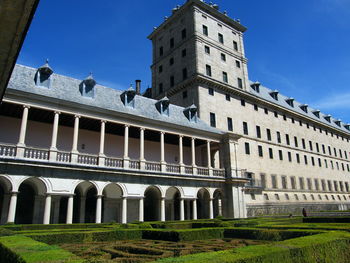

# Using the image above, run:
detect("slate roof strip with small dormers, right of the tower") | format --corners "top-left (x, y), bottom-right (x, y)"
top-left (248, 82), bottom-right (350, 134)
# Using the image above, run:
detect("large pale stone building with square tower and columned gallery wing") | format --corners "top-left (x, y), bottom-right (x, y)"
top-left (0, 0), bottom-right (350, 224)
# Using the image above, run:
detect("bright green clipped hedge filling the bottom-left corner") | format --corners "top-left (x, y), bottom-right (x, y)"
top-left (0, 235), bottom-right (84, 263)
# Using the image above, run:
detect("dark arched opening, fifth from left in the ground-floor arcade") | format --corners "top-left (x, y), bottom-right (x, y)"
top-left (144, 186), bottom-right (162, 221)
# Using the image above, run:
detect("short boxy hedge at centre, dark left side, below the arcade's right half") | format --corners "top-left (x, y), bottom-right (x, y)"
top-left (142, 228), bottom-right (224, 242)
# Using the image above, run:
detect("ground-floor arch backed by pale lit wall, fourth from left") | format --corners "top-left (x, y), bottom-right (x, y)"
top-left (102, 183), bottom-right (126, 222)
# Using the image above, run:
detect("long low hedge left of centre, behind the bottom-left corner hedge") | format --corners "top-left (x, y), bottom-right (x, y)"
top-left (27, 229), bottom-right (142, 245)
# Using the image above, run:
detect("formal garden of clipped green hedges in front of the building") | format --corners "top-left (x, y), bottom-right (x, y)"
top-left (0, 216), bottom-right (350, 263)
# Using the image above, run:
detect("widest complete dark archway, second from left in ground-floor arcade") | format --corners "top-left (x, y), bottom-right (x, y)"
top-left (15, 177), bottom-right (47, 224)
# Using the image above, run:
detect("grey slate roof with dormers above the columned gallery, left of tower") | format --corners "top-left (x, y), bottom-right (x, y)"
top-left (7, 64), bottom-right (223, 134)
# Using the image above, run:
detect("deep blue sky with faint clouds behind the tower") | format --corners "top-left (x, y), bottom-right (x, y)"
top-left (18, 0), bottom-right (350, 122)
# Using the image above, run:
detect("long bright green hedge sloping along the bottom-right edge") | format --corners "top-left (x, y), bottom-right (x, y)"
top-left (153, 232), bottom-right (350, 263)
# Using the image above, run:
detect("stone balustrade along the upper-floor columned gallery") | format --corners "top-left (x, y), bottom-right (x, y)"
top-left (0, 144), bottom-right (225, 177)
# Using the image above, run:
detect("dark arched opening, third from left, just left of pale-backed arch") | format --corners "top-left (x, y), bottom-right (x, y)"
top-left (72, 181), bottom-right (98, 223)
